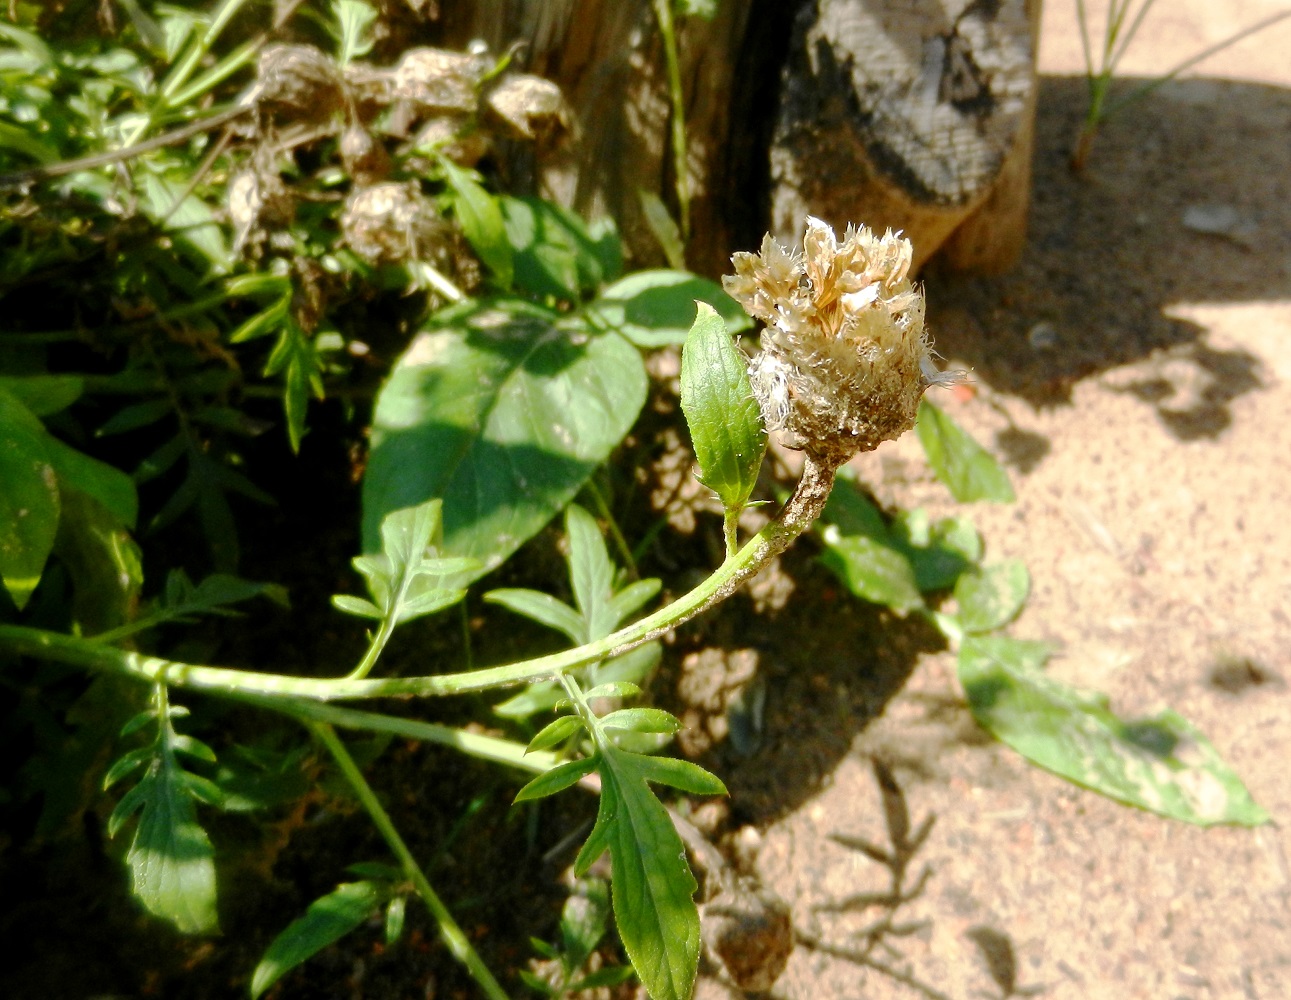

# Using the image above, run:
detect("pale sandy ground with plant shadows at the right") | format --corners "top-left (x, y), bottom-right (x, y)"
top-left (701, 7), bottom-right (1291, 1000)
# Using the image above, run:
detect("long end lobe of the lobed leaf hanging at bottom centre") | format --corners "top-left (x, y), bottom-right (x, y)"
top-left (596, 745), bottom-right (700, 1000)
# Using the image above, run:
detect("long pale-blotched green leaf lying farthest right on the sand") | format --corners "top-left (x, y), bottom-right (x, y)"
top-left (959, 636), bottom-right (1269, 826)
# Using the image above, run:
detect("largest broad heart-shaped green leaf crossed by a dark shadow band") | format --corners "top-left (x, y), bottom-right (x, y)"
top-left (363, 299), bottom-right (646, 586)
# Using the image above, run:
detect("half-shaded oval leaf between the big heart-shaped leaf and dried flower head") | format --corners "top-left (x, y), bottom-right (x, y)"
top-left (584, 271), bottom-right (753, 348)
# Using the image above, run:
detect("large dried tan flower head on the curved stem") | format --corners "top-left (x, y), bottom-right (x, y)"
top-left (722, 217), bottom-right (961, 463)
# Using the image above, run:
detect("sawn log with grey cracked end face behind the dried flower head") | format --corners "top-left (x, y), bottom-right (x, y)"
top-left (771, 0), bottom-right (1039, 270)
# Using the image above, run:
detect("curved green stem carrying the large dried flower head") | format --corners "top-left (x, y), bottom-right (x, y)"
top-left (0, 455), bottom-right (837, 701)
